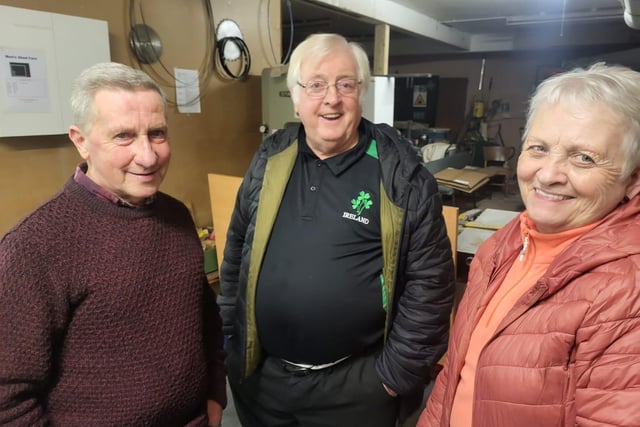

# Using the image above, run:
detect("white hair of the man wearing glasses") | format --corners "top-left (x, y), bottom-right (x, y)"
top-left (287, 33), bottom-right (371, 103)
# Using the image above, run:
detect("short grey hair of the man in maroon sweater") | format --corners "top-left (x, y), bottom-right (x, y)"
top-left (70, 62), bottom-right (167, 132)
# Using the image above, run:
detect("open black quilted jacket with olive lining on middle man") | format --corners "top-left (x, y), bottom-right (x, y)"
top-left (218, 119), bottom-right (454, 395)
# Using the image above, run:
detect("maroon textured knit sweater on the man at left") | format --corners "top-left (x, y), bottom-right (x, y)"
top-left (0, 179), bottom-right (226, 427)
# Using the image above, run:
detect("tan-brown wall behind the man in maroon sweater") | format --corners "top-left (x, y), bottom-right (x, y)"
top-left (0, 0), bottom-right (281, 236)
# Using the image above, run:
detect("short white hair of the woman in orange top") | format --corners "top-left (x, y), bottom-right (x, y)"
top-left (523, 62), bottom-right (640, 177)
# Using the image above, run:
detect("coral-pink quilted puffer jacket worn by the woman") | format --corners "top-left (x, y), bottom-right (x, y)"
top-left (418, 197), bottom-right (640, 427)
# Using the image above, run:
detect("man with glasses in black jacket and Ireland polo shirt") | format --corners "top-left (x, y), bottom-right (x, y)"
top-left (218, 34), bottom-right (453, 427)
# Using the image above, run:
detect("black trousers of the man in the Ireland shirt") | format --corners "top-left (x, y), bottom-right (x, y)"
top-left (229, 354), bottom-right (399, 427)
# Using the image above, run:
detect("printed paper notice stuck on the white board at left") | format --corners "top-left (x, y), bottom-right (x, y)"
top-left (0, 47), bottom-right (50, 113)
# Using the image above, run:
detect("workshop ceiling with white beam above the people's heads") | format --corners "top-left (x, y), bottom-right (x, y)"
top-left (281, 0), bottom-right (640, 68)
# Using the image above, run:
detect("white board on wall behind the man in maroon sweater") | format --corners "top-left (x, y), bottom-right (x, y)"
top-left (0, 6), bottom-right (111, 137)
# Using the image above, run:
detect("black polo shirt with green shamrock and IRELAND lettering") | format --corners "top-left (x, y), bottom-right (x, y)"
top-left (256, 127), bottom-right (385, 364)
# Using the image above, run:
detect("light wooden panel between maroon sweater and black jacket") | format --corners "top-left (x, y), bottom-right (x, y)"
top-left (209, 173), bottom-right (242, 271)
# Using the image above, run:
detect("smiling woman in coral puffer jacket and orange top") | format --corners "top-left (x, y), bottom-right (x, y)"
top-left (418, 64), bottom-right (640, 427)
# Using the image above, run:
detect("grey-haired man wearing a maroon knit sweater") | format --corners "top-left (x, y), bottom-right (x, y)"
top-left (0, 63), bottom-right (226, 427)
